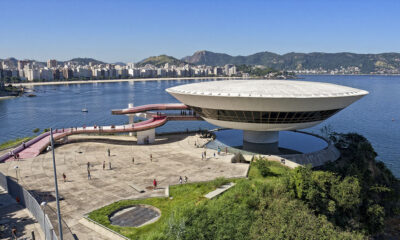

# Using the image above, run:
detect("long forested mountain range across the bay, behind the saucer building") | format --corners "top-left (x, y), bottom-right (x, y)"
top-left (182, 51), bottom-right (400, 73)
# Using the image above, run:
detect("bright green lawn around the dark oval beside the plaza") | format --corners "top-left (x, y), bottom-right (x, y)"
top-left (89, 162), bottom-right (290, 239)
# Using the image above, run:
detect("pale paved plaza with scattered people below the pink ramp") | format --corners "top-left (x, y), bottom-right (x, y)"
top-left (0, 134), bottom-right (249, 239)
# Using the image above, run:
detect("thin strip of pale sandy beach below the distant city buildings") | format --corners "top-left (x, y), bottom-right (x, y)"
top-left (14, 77), bottom-right (242, 86)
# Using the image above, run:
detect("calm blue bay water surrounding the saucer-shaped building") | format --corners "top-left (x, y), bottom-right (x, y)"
top-left (0, 76), bottom-right (400, 177)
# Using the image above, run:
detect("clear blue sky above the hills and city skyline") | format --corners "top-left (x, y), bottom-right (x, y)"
top-left (0, 0), bottom-right (400, 62)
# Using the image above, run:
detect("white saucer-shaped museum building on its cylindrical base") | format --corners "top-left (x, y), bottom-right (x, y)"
top-left (166, 80), bottom-right (368, 151)
